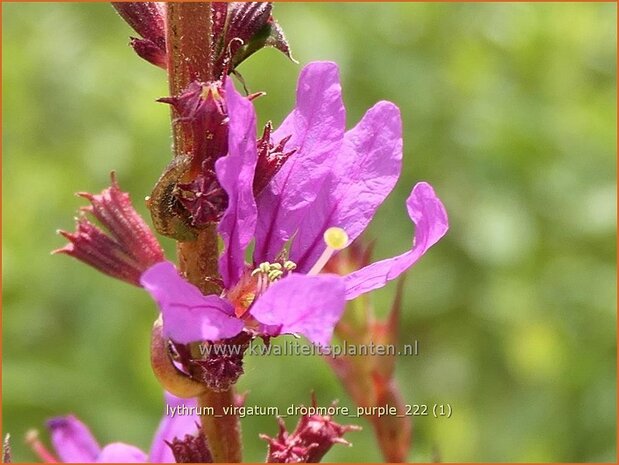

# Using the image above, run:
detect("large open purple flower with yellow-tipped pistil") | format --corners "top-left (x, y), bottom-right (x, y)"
top-left (141, 62), bottom-right (448, 345)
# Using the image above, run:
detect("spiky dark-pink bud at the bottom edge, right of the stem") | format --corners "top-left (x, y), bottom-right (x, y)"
top-left (260, 397), bottom-right (361, 463)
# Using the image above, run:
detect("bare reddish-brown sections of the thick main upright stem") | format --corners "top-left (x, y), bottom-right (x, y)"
top-left (166, 2), bottom-right (242, 463)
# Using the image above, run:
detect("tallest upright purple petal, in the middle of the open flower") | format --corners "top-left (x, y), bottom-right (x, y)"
top-left (254, 62), bottom-right (346, 263)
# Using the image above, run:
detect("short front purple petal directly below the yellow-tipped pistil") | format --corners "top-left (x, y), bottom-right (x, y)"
top-left (250, 274), bottom-right (345, 345)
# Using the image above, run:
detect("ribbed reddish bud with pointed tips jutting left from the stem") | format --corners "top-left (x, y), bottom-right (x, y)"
top-left (53, 173), bottom-right (164, 286)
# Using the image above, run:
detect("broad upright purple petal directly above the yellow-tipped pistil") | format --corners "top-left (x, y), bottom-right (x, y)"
top-left (290, 102), bottom-right (402, 272)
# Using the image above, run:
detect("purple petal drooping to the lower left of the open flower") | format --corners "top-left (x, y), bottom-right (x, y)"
top-left (140, 261), bottom-right (243, 344)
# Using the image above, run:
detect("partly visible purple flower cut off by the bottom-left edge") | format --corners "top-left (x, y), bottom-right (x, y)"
top-left (28, 393), bottom-right (199, 463)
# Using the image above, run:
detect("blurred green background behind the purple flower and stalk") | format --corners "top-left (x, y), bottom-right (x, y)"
top-left (2, 3), bottom-right (617, 462)
